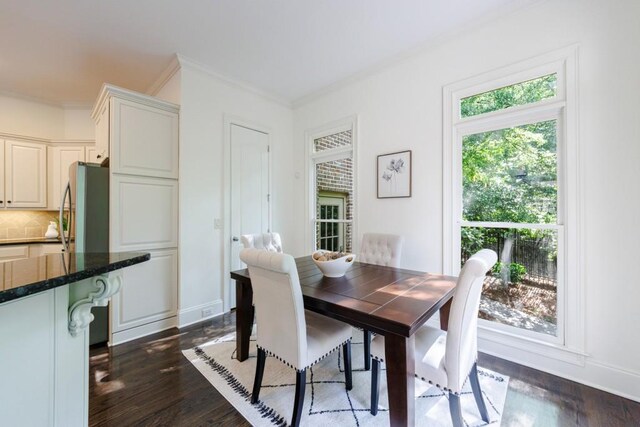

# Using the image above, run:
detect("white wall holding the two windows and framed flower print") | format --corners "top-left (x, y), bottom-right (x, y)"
top-left (294, 0), bottom-right (640, 400)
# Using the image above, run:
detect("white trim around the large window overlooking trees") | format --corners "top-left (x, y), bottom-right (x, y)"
top-left (442, 45), bottom-right (585, 364)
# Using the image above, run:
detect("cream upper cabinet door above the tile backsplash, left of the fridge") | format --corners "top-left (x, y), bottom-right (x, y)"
top-left (5, 140), bottom-right (47, 208)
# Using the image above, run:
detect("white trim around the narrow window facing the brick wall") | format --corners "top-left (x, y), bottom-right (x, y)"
top-left (304, 115), bottom-right (358, 252)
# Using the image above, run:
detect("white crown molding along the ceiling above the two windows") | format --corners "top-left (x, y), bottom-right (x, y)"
top-left (291, 0), bottom-right (550, 110)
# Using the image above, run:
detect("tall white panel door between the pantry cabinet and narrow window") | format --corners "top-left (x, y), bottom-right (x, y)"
top-left (229, 124), bottom-right (270, 308)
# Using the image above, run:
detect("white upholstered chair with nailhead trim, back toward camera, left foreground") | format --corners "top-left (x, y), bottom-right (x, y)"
top-left (240, 249), bottom-right (352, 426)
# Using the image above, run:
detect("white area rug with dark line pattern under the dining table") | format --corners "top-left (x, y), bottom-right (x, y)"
top-left (183, 330), bottom-right (509, 427)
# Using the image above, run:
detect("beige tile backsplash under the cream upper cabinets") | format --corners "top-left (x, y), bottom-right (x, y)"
top-left (0, 210), bottom-right (58, 240)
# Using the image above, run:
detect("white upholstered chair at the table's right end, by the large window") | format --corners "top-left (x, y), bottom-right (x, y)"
top-left (371, 249), bottom-right (498, 427)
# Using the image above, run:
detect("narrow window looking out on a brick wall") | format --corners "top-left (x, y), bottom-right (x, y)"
top-left (308, 121), bottom-right (355, 252)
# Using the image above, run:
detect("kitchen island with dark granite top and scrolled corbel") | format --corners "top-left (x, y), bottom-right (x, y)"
top-left (0, 252), bottom-right (149, 427)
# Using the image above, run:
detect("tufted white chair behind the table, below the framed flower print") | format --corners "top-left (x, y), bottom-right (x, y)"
top-left (358, 233), bottom-right (404, 371)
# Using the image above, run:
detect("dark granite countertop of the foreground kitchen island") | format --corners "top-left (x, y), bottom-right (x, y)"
top-left (0, 252), bottom-right (150, 303)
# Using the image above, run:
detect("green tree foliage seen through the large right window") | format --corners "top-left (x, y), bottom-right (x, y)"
top-left (460, 74), bottom-right (557, 266)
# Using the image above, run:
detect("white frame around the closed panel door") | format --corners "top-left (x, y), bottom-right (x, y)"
top-left (220, 114), bottom-right (274, 313)
